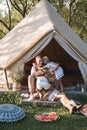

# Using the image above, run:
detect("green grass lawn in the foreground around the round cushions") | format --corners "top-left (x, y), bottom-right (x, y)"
top-left (0, 94), bottom-right (87, 130)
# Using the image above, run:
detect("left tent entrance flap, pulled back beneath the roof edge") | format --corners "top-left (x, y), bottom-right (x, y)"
top-left (9, 32), bottom-right (53, 71)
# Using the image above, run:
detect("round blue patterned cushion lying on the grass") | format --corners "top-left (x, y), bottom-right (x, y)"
top-left (0, 104), bottom-right (25, 122)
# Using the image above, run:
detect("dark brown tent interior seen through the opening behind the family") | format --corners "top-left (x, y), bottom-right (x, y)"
top-left (23, 39), bottom-right (84, 87)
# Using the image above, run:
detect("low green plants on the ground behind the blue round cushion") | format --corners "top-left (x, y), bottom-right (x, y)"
top-left (0, 91), bottom-right (23, 105)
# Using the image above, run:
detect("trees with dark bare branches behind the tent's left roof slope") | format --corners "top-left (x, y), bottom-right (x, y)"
top-left (0, 0), bottom-right (39, 38)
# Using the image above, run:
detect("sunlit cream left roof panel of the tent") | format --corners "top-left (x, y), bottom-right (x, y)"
top-left (0, 1), bottom-right (53, 69)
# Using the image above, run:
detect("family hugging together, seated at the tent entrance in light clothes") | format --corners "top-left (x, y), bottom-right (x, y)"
top-left (28, 55), bottom-right (81, 113)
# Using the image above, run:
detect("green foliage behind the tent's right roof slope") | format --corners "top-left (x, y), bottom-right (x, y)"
top-left (49, 0), bottom-right (87, 43)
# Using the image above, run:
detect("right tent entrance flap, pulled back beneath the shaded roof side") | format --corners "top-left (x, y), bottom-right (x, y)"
top-left (54, 32), bottom-right (87, 85)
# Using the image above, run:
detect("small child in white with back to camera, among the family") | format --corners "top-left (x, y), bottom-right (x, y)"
top-left (36, 68), bottom-right (53, 100)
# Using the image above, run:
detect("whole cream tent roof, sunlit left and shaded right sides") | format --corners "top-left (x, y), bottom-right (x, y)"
top-left (0, 0), bottom-right (87, 69)
